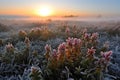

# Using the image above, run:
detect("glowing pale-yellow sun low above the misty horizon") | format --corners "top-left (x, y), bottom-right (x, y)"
top-left (38, 6), bottom-right (52, 17)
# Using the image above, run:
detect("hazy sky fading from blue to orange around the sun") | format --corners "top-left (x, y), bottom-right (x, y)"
top-left (0, 0), bottom-right (120, 16)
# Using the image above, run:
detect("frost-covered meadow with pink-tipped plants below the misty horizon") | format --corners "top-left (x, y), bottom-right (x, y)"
top-left (0, 19), bottom-right (120, 80)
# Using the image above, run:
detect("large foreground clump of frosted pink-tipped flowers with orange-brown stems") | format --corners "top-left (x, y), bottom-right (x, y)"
top-left (38, 33), bottom-right (112, 80)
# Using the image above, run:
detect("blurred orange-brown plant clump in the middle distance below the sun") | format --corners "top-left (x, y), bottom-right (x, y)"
top-left (18, 26), bottom-right (55, 40)
